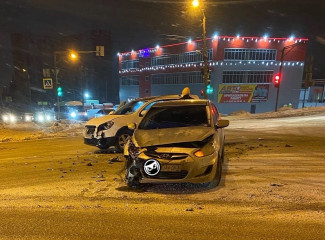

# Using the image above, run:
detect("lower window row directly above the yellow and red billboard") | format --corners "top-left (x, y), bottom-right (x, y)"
top-left (222, 70), bottom-right (273, 83)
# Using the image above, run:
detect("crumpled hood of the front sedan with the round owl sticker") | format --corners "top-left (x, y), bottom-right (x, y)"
top-left (134, 126), bottom-right (215, 147)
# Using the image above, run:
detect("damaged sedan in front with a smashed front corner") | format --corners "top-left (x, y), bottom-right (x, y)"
top-left (124, 100), bottom-right (229, 187)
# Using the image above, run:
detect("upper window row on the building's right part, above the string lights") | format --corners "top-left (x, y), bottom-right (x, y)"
top-left (224, 48), bottom-right (276, 61)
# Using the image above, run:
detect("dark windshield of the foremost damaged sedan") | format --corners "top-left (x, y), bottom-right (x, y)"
top-left (139, 105), bottom-right (208, 130)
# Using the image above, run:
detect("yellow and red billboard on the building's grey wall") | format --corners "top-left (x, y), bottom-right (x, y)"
top-left (218, 84), bottom-right (269, 103)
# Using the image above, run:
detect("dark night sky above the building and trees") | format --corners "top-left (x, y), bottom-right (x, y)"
top-left (0, 0), bottom-right (325, 86)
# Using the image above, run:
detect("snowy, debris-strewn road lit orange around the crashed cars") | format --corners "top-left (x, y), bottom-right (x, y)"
top-left (0, 115), bottom-right (325, 240)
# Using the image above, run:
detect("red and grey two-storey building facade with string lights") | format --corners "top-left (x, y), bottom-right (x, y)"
top-left (118, 36), bottom-right (308, 114)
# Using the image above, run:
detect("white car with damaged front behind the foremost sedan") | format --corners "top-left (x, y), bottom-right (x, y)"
top-left (84, 95), bottom-right (198, 152)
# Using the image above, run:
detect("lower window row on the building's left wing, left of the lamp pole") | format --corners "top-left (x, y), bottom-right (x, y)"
top-left (151, 72), bottom-right (203, 85)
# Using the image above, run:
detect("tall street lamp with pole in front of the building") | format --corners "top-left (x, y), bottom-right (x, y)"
top-left (192, 0), bottom-right (210, 99)
